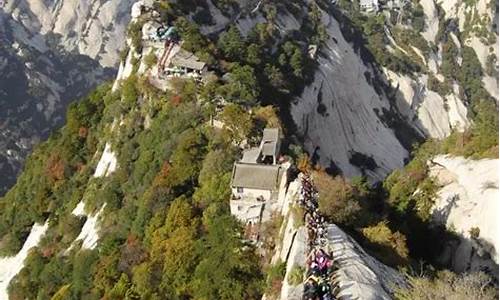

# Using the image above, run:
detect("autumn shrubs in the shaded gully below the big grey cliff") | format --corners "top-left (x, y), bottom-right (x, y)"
top-left (314, 95), bottom-right (498, 267)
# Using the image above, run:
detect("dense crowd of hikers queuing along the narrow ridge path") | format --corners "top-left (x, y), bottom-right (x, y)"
top-left (298, 174), bottom-right (335, 300)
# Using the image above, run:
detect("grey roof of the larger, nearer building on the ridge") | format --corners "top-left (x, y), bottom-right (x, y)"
top-left (231, 163), bottom-right (281, 190)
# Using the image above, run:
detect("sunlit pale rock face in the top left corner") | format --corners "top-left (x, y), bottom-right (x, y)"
top-left (4, 0), bottom-right (134, 67)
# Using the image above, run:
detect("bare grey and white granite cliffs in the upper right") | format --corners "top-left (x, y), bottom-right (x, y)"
top-left (289, 0), bottom-right (498, 180)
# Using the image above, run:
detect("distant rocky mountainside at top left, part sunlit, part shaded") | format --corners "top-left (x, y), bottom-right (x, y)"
top-left (0, 1), bottom-right (132, 194)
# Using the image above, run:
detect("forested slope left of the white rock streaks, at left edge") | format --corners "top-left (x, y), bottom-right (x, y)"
top-left (0, 85), bottom-right (113, 255)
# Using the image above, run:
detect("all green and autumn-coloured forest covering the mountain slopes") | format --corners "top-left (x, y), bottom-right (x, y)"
top-left (0, 0), bottom-right (498, 299)
